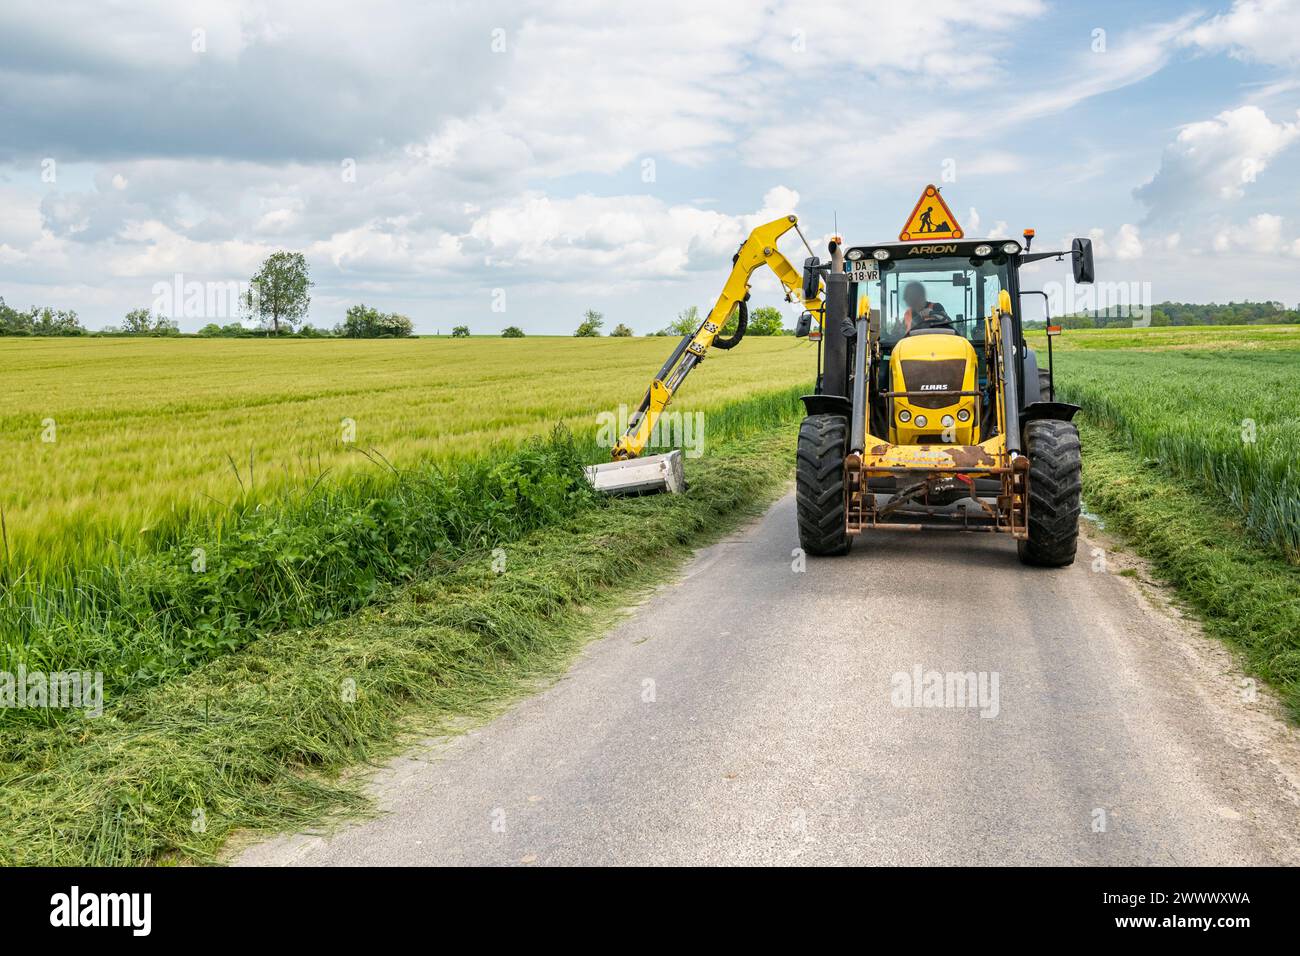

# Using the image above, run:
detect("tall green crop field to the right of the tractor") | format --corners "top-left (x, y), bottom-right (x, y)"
top-left (1057, 349), bottom-right (1300, 562)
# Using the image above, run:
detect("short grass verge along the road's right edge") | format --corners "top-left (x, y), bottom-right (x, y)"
top-left (1079, 421), bottom-right (1300, 721)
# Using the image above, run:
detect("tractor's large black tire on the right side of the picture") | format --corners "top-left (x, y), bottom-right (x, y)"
top-left (1017, 420), bottom-right (1083, 567)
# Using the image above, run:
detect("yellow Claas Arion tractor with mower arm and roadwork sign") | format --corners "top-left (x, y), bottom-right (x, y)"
top-left (593, 186), bottom-right (1093, 567)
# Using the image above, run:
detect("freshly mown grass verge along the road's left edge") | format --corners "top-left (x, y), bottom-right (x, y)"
top-left (0, 421), bottom-right (797, 865)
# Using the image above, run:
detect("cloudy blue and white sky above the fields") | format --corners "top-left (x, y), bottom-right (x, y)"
top-left (0, 0), bottom-right (1300, 333)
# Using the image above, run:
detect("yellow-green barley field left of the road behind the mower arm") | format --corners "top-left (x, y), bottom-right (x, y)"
top-left (0, 337), bottom-right (816, 570)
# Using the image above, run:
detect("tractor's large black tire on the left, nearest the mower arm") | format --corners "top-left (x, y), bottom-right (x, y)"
top-left (794, 415), bottom-right (853, 555)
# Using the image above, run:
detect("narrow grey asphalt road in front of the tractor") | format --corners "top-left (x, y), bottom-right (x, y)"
top-left (235, 497), bottom-right (1300, 865)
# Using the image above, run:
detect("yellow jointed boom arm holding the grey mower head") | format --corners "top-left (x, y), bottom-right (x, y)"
top-left (614, 216), bottom-right (823, 460)
